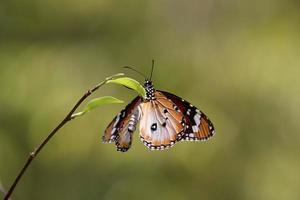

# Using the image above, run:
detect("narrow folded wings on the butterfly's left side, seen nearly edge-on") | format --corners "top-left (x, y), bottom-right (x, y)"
top-left (102, 97), bottom-right (141, 152)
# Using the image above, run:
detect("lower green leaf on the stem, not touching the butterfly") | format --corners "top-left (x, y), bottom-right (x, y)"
top-left (71, 96), bottom-right (124, 119)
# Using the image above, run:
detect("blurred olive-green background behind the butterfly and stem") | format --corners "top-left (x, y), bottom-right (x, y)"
top-left (0, 0), bottom-right (300, 200)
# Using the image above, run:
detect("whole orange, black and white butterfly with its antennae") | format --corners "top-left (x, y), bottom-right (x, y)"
top-left (102, 61), bottom-right (215, 152)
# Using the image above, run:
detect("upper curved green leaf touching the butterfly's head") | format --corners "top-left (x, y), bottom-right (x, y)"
top-left (107, 77), bottom-right (146, 98)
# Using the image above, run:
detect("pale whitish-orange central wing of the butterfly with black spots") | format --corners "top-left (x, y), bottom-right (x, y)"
top-left (140, 92), bottom-right (184, 150)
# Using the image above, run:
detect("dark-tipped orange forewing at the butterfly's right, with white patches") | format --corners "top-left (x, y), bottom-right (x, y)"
top-left (157, 91), bottom-right (215, 141)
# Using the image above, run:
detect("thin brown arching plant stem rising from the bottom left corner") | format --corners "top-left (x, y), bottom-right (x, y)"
top-left (4, 73), bottom-right (124, 200)
